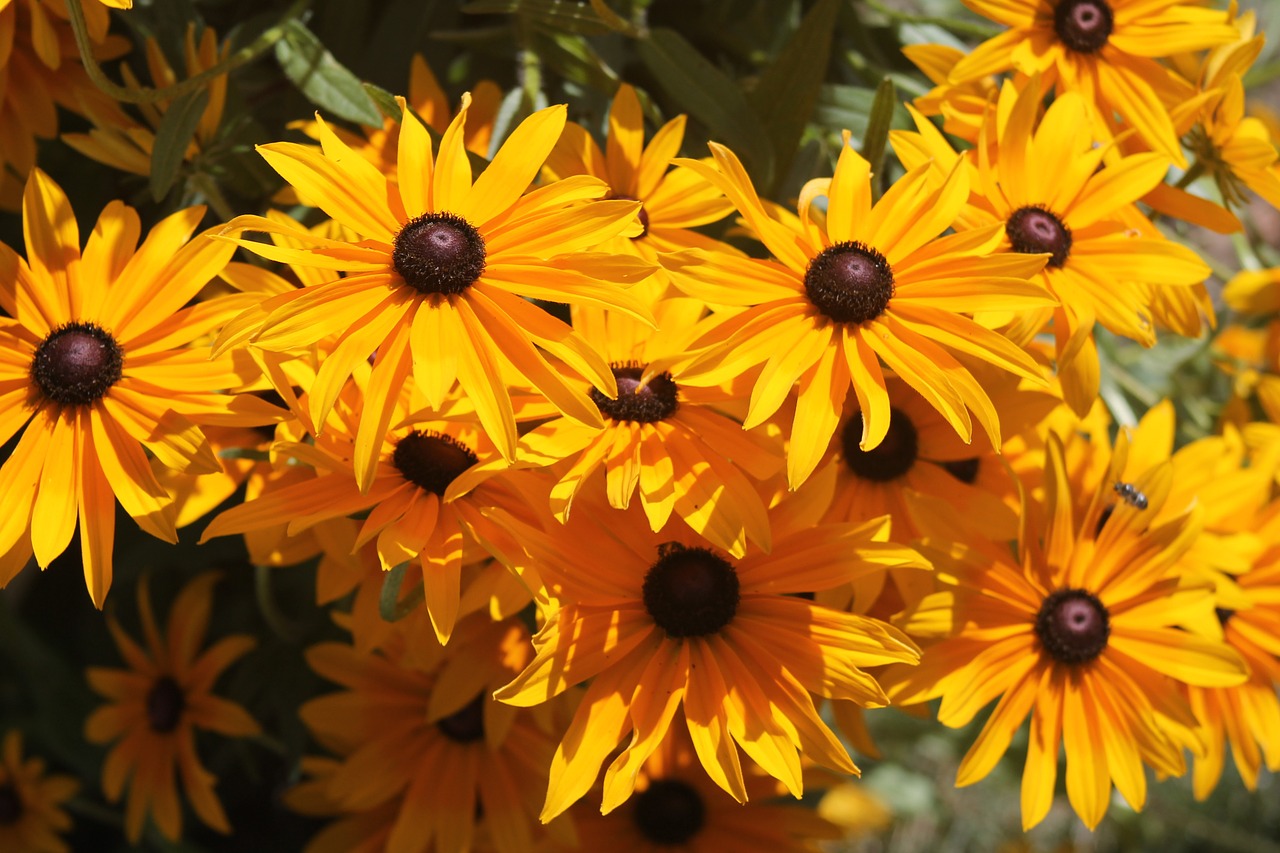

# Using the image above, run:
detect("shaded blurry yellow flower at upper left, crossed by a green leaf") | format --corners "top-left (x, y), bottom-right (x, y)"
top-left (63, 23), bottom-right (230, 175)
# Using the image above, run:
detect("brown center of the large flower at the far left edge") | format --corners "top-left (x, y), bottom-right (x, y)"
top-left (31, 323), bottom-right (124, 406)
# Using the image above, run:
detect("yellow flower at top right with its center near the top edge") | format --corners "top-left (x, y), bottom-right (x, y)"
top-left (950, 0), bottom-right (1236, 166)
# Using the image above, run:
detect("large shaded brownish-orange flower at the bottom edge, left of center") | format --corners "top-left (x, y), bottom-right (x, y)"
top-left (300, 611), bottom-right (568, 853)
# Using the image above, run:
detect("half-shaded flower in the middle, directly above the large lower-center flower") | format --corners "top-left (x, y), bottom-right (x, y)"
top-left (520, 297), bottom-right (782, 556)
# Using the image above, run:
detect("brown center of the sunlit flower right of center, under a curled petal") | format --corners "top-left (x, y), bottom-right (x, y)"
top-left (804, 241), bottom-right (893, 323)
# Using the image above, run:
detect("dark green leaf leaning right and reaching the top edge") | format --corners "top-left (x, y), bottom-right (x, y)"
top-left (750, 0), bottom-right (840, 192)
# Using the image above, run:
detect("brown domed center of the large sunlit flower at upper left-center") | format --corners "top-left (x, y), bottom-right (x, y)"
top-left (392, 213), bottom-right (485, 296)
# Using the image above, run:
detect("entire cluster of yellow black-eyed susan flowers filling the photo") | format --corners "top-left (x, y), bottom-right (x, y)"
top-left (0, 0), bottom-right (1280, 853)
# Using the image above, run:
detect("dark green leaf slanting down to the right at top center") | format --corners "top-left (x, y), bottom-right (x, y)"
top-left (639, 28), bottom-right (773, 187)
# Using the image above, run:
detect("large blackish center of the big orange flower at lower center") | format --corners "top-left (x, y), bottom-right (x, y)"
top-left (643, 542), bottom-right (739, 638)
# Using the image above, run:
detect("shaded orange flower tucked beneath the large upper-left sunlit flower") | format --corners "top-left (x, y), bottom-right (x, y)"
top-left (201, 376), bottom-right (535, 643)
